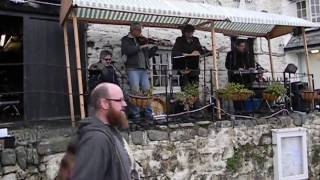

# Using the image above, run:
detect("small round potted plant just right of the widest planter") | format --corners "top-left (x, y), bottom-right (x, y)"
top-left (262, 83), bottom-right (287, 102)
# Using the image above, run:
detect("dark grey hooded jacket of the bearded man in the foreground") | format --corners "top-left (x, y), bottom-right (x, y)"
top-left (71, 118), bottom-right (131, 180)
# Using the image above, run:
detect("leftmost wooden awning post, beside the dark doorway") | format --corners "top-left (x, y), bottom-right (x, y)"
top-left (63, 22), bottom-right (75, 127)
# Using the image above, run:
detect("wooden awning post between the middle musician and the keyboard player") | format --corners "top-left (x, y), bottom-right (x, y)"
top-left (211, 24), bottom-right (221, 119)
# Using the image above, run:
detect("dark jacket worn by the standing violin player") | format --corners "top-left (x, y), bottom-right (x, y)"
top-left (121, 35), bottom-right (158, 69)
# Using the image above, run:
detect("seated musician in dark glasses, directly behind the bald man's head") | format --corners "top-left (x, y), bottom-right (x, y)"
top-left (88, 50), bottom-right (119, 91)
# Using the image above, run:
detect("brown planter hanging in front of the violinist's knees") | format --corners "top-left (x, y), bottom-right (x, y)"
top-left (129, 90), bottom-right (152, 109)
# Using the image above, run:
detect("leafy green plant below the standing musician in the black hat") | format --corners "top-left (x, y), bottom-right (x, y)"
top-left (177, 84), bottom-right (199, 111)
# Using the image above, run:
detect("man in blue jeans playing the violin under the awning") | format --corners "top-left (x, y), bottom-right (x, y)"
top-left (121, 22), bottom-right (157, 118)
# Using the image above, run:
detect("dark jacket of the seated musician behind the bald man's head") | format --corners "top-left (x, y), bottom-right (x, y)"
top-left (88, 62), bottom-right (119, 91)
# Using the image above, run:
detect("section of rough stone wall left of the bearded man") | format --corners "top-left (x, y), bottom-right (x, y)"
top-left (0, 124), bottom-right (74, 180)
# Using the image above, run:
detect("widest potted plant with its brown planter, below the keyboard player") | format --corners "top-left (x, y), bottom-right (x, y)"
top-left (217, 83), bottom-right (255, 101)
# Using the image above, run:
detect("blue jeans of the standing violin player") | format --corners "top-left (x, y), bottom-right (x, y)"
top-left (127, 69), bottom-right (152, 117)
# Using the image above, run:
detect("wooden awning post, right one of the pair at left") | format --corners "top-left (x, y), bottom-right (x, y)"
top-left (72, 16), bottom-right (86, 119)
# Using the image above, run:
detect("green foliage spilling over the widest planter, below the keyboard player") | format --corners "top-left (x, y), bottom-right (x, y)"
top-left (217, 83), bottom-right (255, 100)
